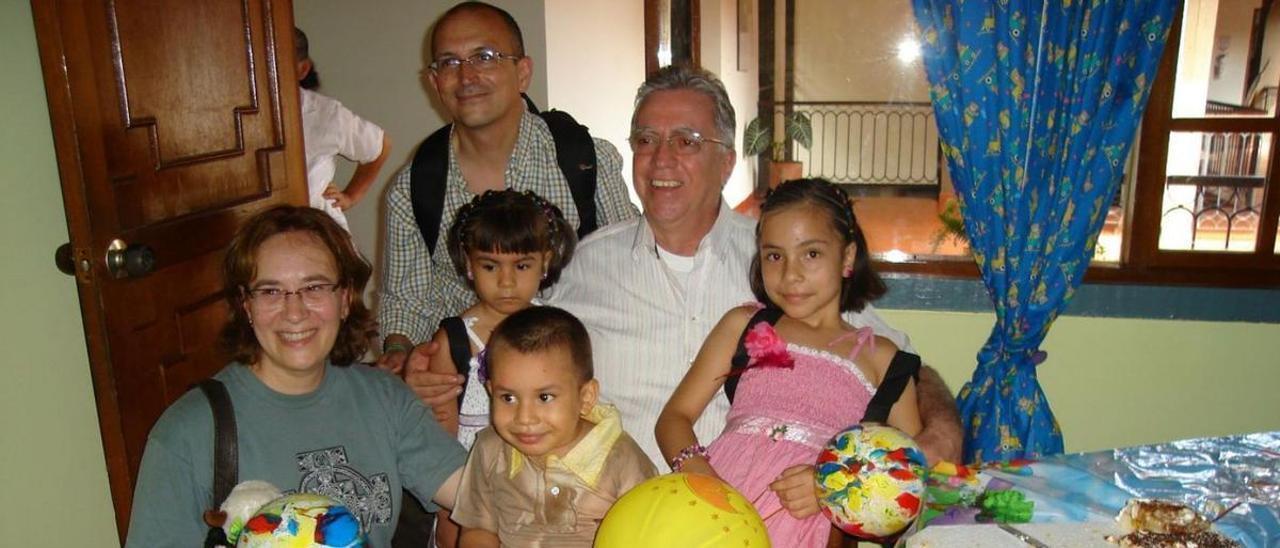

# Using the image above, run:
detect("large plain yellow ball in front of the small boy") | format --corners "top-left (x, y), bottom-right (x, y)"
top-left (595, 474), bottom-right (769, 548)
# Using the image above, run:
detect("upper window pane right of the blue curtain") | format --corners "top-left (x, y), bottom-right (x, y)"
top-left (1172, 0), bottom-right (1280, 118)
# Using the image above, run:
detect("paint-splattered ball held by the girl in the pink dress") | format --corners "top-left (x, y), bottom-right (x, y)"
top-left (814, 424), bottom-right (928, 540)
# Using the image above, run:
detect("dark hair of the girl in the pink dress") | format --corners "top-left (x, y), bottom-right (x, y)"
top-left (751, 179), bottom-right (888, 312)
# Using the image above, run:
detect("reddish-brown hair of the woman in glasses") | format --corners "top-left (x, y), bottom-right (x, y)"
top-left (219, 206), bottom-right (378, 365)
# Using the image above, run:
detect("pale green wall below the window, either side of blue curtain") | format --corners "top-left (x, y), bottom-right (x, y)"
top-left (884, 310), bottom-right (1280, 451)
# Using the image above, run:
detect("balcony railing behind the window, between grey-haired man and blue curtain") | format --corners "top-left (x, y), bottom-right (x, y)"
top-left (773, 101), bottom-right (941, 192)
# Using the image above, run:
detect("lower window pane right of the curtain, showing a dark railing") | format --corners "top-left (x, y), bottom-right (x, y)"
top-left (1160, 132), bottom-right (1272, 252)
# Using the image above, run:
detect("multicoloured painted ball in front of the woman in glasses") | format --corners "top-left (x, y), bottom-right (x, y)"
top-left (236, 493), bottom-right (365, 548)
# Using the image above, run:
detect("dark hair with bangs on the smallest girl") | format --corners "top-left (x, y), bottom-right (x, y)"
top-left (448, 188), bottom-right (577, 289)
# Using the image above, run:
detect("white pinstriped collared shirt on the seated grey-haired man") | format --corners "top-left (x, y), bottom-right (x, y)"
top-left (548, 202), bottom-right (909, 465)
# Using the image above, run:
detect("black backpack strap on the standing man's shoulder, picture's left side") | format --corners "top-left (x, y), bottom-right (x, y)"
top-left (408, 124), bottom-right (453, 256)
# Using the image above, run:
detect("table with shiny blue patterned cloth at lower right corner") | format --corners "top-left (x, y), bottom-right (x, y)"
top-left (899, 431), bottom-right (1280, 548)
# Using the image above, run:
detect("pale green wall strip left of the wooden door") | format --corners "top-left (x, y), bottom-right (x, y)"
top-left (0, 1), bottom-right (116, 547)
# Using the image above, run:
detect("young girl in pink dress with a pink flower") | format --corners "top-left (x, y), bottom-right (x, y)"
top-left (657, 179), bottom-right (920, 547)
